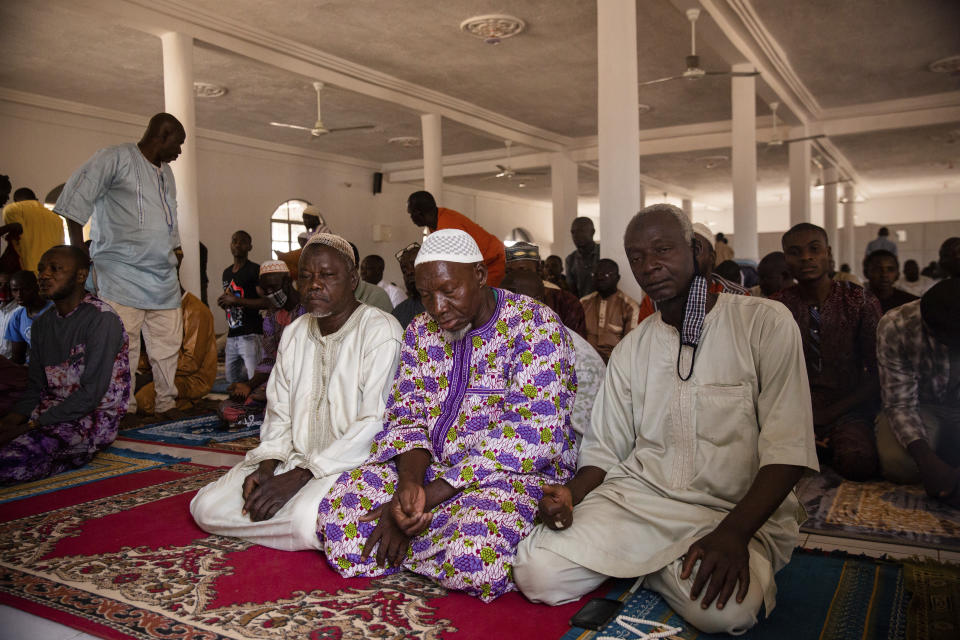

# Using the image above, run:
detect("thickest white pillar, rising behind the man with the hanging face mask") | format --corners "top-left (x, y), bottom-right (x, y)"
top-left (597, 0), bottom-right (642, 300)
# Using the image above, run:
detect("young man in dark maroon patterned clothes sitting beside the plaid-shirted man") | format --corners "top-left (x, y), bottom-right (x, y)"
top-left (770, 222), bottom-right (883, 481)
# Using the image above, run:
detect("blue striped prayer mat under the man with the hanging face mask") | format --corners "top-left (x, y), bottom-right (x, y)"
top-left (561, 549), bottom-right (924, 640)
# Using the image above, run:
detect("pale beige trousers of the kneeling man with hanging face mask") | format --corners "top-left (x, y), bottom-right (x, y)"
top-left (513, 525), bottom-right (776, 635)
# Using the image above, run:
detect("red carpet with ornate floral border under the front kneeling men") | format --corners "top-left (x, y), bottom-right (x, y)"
top-left (0, 464), bottom-right (605, 640)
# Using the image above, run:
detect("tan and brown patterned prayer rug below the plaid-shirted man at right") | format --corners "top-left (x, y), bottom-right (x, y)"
top-left (797, 468), bottom-right (960, 551)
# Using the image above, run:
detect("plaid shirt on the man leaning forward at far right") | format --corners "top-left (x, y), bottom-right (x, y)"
top-left (877, 300), bottom-right (960, 447)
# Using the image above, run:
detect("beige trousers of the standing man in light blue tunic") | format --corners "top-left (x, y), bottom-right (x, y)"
top-left (104, 300), bottom-right (183, 414)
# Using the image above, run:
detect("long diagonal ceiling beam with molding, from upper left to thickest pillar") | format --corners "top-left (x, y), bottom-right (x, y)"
top-left (77, 0), bottom-right (571, 151)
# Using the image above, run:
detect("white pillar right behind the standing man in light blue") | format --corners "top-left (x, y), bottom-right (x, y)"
top-left (160, 33), bottom-right (201, 298)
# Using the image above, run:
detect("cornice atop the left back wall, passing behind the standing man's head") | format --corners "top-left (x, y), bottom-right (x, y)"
top-left (0, 87), bottom-right (380, 171)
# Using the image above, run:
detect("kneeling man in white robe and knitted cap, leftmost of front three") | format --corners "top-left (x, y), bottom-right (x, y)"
top-left (190, 233), bottom-right (402, 551)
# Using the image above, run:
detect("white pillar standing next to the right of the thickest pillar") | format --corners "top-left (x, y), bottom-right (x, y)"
top-left (731, 64), bottom-right (760, 260)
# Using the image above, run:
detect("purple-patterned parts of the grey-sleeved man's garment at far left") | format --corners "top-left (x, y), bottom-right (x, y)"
top-left (0, 294), bottom-right (130, 484)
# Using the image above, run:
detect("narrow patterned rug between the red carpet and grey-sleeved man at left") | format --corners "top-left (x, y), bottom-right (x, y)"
top-left (0, 447), bottom-right (188, 504)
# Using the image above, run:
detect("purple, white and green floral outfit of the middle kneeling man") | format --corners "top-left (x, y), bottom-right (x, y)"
top-left (317, 290), bottom-right (577, 602)
